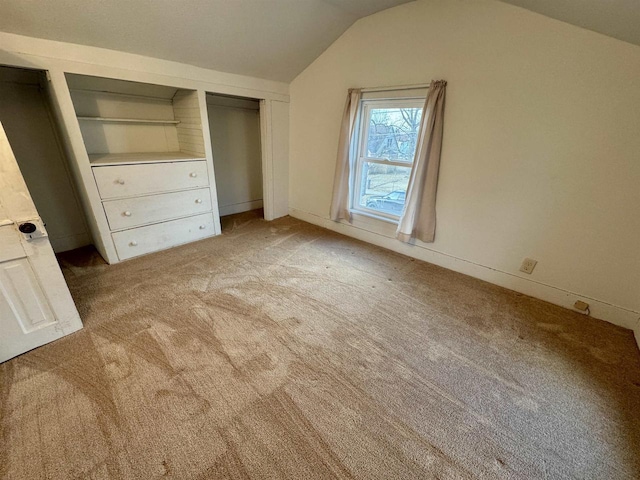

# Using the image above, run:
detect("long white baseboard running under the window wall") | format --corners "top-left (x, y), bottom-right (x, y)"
top-left (289, 208), bottom-right (640, 347)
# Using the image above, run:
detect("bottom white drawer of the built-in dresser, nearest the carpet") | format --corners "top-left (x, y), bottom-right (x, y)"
top-left (111, 213), bottom-right (215, 260)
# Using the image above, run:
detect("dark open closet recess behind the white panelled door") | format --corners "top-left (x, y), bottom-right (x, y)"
top-left (0, 66), bottom-right (92, 254)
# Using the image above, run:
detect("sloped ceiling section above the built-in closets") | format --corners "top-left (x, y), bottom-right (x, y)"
top-left (0, 0), bottom-right (410, 82)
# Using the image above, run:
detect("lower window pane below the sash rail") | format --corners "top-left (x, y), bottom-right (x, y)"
top-left (358, 162), bottom-right (411, 216)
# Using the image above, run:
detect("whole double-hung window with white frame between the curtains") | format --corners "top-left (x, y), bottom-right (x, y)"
top-left (351, 98), bottom-right (424, 221)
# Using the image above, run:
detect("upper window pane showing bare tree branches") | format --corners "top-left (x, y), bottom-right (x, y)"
top-left (366, 108), bottom-right (422, 162)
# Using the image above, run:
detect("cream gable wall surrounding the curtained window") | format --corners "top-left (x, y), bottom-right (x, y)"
top-left (290, 0), bottom-right (640, 334)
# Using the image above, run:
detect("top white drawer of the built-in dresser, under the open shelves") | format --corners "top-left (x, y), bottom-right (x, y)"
top-left (93, 160), bottom-right (209, 200)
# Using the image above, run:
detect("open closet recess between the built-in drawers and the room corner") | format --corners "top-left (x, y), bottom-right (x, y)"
top-left (207, 93), bottom-right (264, 230)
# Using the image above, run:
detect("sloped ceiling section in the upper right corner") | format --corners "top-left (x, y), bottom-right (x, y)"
top-left (501, 0), bottom-right (640, 45)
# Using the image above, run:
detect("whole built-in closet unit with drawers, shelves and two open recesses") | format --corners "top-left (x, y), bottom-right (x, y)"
top-left (0, 67), bottom-right (288, 263)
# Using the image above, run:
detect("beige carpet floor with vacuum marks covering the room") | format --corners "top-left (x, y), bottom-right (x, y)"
top-left (0, 213), bottom-right (640, 480)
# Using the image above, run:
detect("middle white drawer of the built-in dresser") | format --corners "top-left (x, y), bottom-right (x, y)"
top-left (103, 188), bottom-right (211, 230)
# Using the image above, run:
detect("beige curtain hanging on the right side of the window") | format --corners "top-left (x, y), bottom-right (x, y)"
top-left (396, 80), bottom-right (447, 243)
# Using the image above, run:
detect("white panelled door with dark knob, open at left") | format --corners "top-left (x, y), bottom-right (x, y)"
top-left (0, 124), bottom-right (82, 362)
